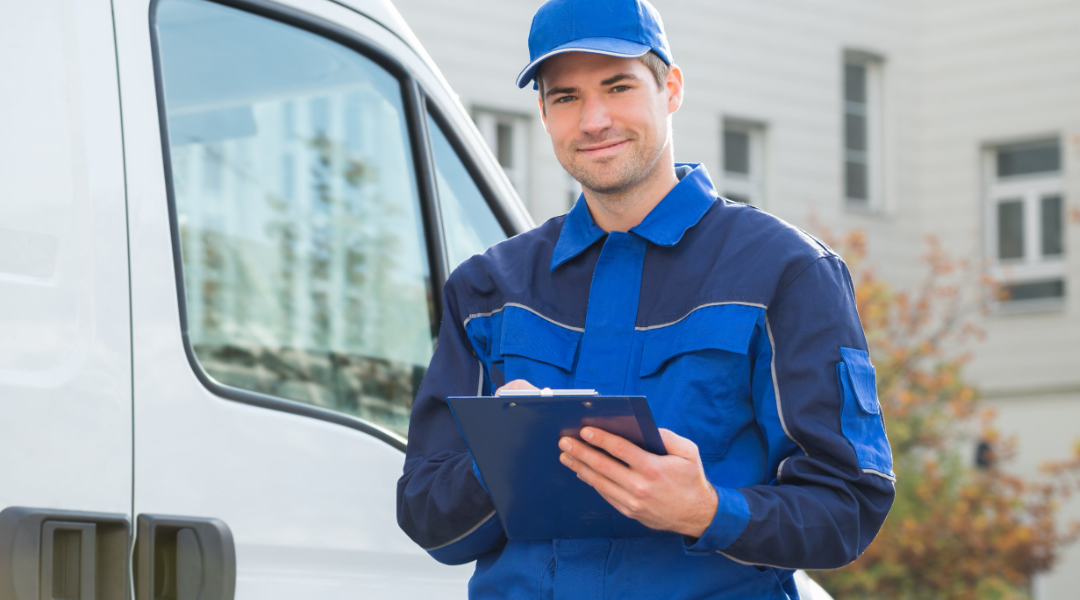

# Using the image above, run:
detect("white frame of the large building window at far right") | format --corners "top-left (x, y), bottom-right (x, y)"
top-left (981, 134), bottom-right (1069, 313)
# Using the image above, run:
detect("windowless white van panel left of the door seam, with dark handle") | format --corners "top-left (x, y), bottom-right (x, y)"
top-left (0, 0), bottom-right (132, 598)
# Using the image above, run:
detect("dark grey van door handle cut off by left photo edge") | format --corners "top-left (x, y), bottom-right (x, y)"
top-left (0, 506), bottom-right (131, 600)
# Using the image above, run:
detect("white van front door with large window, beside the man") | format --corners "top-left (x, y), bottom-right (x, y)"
top-left (116, 0), bottom-right (514, 600)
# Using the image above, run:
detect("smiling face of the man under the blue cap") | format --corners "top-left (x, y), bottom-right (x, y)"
top-left (540, 52), bottom-right (681, 194)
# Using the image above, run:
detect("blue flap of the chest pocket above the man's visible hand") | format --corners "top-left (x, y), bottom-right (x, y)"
top-left (640, 304), bottom-right (761, 377)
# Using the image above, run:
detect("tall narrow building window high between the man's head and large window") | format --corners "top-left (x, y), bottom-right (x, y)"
top-left (843, 51), bottom-right (883, 209)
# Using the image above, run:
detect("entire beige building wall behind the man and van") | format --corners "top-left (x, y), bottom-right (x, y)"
top-left (395, 0), bottom-right (1080, 600)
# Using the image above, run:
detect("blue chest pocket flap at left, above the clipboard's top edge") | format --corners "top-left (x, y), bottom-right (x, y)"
top-left (500, 306), bottom-right (581, 371)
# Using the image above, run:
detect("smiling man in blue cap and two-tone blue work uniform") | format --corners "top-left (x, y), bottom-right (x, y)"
top-left (397, 0), bottom-right (894, 599)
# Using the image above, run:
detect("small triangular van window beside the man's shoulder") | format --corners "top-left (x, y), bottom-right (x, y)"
top-left (428, 114), bottom-right (507, 269)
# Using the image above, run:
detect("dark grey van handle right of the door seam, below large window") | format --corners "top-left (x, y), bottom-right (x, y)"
top-left (135, 515), bottom-right (237, 600)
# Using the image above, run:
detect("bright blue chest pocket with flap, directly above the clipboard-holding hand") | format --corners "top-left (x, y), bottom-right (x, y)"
top-left (639, 304), bottom-right (761, 461)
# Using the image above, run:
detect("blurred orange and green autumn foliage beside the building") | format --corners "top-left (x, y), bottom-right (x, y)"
top-left (814, 228), bottom-right (1080, 600)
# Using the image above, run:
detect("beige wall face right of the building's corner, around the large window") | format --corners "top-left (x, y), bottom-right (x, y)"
top-left (914, 0), bottom-right (1080, 599)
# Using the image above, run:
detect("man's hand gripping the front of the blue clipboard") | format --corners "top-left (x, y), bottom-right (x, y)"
top-left (558, 427), bottom-right (718, 537)
